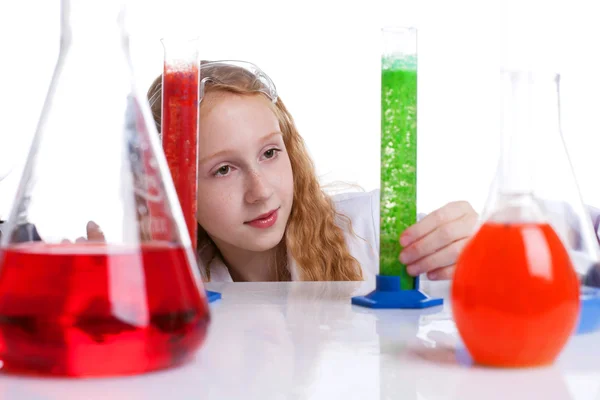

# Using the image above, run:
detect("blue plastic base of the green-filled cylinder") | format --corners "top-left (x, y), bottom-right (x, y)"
top-left (352, 275), bottom-right (444, 308)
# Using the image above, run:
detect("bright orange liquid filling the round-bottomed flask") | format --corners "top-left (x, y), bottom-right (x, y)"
top-left (451, 223), bottom-right (579, 367)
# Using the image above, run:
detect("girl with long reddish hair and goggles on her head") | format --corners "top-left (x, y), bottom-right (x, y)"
top-left (148, 61), bottom-right (477, 281)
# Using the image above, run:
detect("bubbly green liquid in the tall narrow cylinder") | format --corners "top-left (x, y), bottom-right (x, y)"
top-left (379, 59), bottom-right (417, 289)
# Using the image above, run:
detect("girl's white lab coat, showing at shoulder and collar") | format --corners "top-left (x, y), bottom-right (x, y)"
top-left (210, 190), bottom-right (379, 282)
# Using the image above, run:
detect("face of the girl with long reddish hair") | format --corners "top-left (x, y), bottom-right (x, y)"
top-left (197, 93), bottom-right (294, 252)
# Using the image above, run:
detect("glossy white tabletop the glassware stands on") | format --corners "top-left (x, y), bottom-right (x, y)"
top-left (0, 282), bottom-right (600, 400)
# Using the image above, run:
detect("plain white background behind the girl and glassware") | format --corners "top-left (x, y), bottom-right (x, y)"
top-left (0, 0), bottom-right (600, 217)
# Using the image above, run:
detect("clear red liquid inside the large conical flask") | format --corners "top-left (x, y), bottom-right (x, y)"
top-left (0, 243), bottom-right (210, 376)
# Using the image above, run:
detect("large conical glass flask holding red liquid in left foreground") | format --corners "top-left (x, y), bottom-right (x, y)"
top-left (0, 0), bottom-right (209, 376)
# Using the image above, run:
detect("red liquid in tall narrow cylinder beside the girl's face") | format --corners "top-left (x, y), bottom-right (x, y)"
top-left (162, 64), bottom-right (199, 248)
